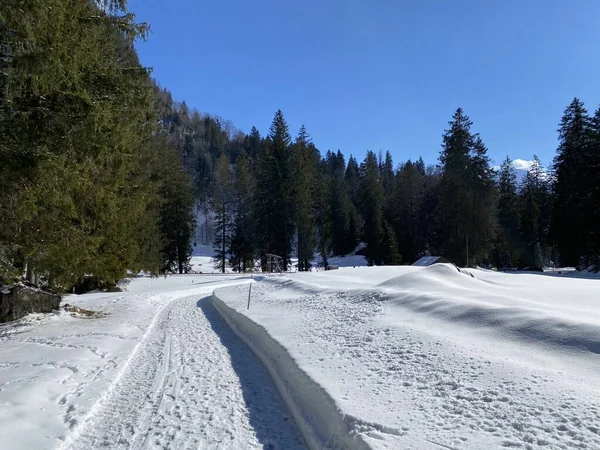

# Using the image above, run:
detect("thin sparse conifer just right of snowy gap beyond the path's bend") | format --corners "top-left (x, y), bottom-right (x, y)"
top-left (212, 153), bottom-right (233, 273)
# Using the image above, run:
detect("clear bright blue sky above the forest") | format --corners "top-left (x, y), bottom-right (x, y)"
top-left (129, 0), bottom-right (600, 168)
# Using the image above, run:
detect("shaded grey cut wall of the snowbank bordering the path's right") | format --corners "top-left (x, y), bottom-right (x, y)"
top-left (212, 291), bottom-right (370, 450)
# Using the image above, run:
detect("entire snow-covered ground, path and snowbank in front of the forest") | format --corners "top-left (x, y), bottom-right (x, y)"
top-left (0, 264), bottom-right (600, 450)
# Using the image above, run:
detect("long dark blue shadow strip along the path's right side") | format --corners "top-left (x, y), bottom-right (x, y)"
top-left (197, 297), bottom-right (306, 450)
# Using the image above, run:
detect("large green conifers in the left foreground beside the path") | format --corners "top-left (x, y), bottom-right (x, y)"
top-left (0, 0), bottom-right (195, 290)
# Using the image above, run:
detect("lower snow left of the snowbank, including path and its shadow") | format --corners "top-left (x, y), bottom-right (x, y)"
top-left (0, 275), bottom-right (304, 450)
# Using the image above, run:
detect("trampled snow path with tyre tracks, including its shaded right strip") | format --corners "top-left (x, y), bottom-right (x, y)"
top-left (62, 296), bottom-right (304, 449)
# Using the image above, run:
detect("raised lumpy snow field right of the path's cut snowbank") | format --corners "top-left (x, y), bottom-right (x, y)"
top-left (215, 265), bottom-right (600, 449)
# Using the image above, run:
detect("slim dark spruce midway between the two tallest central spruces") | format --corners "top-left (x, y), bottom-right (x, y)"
top-left (360, 151), bottom-right (384, 266)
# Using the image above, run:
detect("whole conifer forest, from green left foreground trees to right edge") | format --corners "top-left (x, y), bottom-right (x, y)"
top-left (0, 0), bottom-right (600, 291)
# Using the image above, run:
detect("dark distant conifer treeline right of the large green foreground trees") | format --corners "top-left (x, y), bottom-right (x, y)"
top-left (186, 99), bottom-right (600, 271)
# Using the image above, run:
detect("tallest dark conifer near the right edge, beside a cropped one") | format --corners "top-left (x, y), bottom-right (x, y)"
top-left (551, 98), bottom-right (590, 266)
